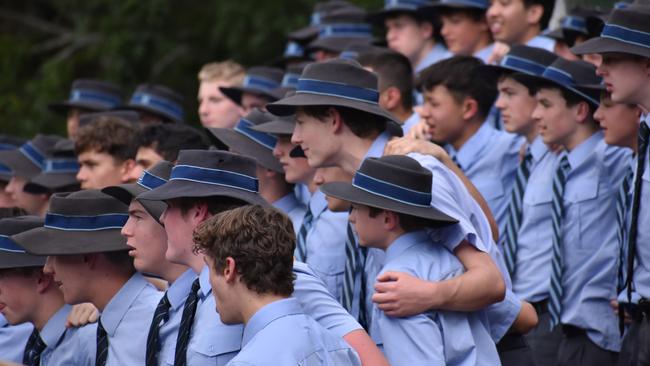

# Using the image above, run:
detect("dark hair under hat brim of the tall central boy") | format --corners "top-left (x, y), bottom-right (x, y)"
top-left (298, 105), bottom-right (386, 138)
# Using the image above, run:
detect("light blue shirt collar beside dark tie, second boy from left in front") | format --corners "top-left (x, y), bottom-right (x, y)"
top-left (101, 272), bottom-right (149, 336)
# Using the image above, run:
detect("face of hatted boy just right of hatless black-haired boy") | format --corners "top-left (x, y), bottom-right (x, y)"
top-left (494, 76), bottom-right (537, 136)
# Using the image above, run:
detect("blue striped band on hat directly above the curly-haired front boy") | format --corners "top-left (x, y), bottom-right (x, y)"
top-left (169, 165), bottom-right (259, 193)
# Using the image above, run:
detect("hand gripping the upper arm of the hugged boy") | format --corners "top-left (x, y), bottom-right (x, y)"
top-left (372, 272), bottom-right (437, 317)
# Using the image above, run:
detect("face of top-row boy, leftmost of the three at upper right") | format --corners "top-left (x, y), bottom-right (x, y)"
top-left (384, 14), bottom-right (433, 61)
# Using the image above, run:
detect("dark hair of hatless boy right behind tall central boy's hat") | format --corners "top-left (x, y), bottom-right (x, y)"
top-left (357, 51), bottom-right (413, 110)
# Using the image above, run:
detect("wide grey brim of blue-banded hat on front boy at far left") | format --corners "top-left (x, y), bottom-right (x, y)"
top-left (11, 227), bottom-right (129, 255)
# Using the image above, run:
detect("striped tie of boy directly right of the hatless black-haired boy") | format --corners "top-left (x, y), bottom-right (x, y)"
top-left (501, 146), bottom-right (533, 277)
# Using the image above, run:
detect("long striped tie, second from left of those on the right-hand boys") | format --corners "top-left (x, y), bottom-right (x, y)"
top-left (548, 155), bottom-right (571, 329)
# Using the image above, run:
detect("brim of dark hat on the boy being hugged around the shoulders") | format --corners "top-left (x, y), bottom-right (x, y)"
top-left (320, 182), bottom-right (458, 226)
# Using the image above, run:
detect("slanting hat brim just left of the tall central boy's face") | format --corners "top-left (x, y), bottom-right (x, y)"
top-left (209, 128), bottom-right (284, 174)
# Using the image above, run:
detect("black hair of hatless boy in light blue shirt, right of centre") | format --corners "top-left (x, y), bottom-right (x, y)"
top-left (418, 56), bottom-right (497, 118)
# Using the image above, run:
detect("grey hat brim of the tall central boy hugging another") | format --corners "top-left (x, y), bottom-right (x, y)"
top-left (266, 93), bottom-right (404, 137)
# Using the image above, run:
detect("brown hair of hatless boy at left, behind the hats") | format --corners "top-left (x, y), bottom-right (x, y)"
top-left (75, 116), bottom-right (138, 161)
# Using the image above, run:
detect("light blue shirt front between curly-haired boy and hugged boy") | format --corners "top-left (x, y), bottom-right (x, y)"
top-left (306, 190), bottom-right (348, 299)
